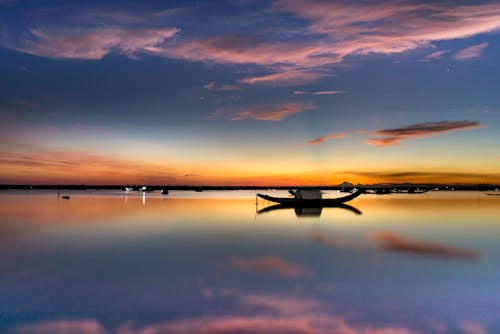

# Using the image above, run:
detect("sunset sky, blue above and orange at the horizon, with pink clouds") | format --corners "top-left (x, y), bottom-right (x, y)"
top-left (0, 0), bottom-right (500, 185)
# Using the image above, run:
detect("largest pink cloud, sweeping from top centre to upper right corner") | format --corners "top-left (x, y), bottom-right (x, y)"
top-left (163, 0), bottom-right (500, 74)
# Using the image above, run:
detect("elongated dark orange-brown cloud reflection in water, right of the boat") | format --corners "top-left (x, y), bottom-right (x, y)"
top-left (371, 231), bottom-right (481, 260)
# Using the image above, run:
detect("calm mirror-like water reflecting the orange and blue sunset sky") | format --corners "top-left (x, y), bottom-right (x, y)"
top-left (0, 191), bottom-right (500, 334)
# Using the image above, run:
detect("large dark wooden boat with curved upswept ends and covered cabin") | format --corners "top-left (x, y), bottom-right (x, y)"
top-left (257, 189), bottom-right (364, 208)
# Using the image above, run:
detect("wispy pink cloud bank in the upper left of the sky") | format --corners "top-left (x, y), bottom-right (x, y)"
top-left (12, 28), bottom-right (179, 59)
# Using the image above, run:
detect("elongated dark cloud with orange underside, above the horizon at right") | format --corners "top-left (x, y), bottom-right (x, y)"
top-left (365, 121), bottom-right (482, 147)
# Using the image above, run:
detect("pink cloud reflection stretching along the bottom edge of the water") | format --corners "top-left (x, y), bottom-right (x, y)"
top-left (14, 293), bottom-right (419, 334)
